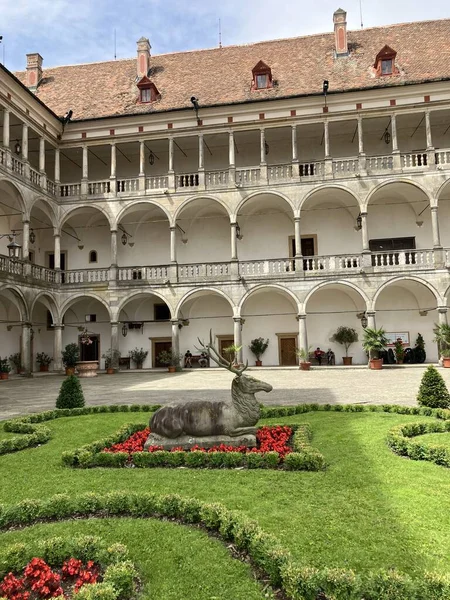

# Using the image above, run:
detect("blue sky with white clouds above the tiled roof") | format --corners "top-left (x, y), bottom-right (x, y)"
top-left (0, 0), bottom-right (450, 71)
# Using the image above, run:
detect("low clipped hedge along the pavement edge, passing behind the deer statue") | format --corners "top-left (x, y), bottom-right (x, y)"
top-left (0, 404), bottom-right (450, 456)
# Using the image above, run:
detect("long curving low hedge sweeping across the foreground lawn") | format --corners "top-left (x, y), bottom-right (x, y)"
top-left (0, 491), bottom-right (450, 600)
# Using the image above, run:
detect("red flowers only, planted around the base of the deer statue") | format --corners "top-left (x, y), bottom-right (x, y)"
top-left (103, 425), bottom-right (292, 458)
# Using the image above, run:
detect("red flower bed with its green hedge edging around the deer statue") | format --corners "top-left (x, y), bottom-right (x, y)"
top-left (62, 424), bottom-right (325, 471)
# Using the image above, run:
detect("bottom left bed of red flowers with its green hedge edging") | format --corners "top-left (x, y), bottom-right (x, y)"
top-left (0, 536), bottom-right (137, 600)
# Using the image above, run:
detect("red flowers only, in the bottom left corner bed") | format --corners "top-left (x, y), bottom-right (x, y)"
top-left (0, 558), bottom-right (99, 600)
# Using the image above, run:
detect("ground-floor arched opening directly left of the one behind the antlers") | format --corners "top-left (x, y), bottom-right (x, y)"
top-left (119, 293), bottom-right (172, 369)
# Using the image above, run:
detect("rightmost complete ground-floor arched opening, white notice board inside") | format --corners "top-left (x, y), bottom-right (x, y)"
top-left (374, 279), bottom-right (438, 362)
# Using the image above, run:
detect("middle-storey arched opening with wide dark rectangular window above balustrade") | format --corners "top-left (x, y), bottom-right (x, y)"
top-left (367, 182), bottom-right (433, 266)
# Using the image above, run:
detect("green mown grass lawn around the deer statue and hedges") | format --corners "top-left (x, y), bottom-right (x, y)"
top-left (0, 411), bottom-right (450, 600)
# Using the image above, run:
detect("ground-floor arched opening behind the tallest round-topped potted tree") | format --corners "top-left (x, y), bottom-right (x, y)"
top-left (305, 283), bottom-right (367, 365)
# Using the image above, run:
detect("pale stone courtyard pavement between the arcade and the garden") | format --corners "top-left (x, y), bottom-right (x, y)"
top-left (0, 366), bottom-right (450, 419)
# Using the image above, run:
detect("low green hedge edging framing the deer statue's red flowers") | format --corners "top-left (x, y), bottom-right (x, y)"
top-left (62, 423), bottom-right (325, 471)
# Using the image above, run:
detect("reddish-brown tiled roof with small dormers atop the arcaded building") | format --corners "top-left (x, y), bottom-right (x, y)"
top-left (16, 19), bottom-right (450, 120)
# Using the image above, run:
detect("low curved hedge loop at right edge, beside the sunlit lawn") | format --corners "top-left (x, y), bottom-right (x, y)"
top-left (387, 421), bottom-right (450, 469)
